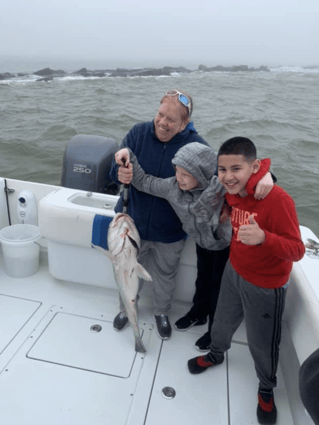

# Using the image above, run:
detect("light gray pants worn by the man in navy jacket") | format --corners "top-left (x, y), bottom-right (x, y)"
top-left (120, 240), bottom-right (185, 316)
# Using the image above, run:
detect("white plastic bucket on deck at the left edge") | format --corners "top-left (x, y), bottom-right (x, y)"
top-left (0, 224), bottom-right (41, 277)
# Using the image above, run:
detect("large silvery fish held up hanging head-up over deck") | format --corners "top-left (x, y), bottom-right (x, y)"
top-left (93, 213), bottom-right (152, 353)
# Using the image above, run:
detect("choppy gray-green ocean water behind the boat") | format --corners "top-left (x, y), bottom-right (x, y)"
top-left (0, 65), bottom-right (319, 236)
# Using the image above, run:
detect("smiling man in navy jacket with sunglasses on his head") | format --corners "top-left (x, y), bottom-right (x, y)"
top-left (110, 90), bottom-right (208, 339)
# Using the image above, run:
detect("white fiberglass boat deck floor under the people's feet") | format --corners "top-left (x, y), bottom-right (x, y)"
top-left (0, 250), bottom-right (301, 425)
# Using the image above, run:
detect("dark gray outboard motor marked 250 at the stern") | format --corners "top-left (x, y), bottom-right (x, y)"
top-left (61, 134), bottom-right (120, 195)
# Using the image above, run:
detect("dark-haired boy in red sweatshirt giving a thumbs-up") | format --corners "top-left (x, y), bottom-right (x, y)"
top-left (188, 137), bottom-right (305, 424)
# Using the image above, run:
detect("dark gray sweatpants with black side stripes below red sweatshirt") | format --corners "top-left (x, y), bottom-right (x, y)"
top-left (210, 260), bottom-right (288, 388)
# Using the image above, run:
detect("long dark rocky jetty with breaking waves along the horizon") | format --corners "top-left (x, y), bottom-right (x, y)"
top-left (0, 65), bottom-right (270, 82)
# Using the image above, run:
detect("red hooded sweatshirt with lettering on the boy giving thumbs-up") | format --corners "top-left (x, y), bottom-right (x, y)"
top-left (226, 159), bottom-right (305, 289)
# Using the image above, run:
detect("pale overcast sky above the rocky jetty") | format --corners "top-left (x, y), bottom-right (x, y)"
top-left (0, 0), bottom-right (319, 67)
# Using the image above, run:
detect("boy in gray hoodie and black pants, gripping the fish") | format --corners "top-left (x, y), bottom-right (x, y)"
top-left (115, 142), bottom-right (273, 351)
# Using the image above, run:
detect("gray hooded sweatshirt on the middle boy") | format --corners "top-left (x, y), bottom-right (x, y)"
top-left (130, 142), bottom-right (232, 251)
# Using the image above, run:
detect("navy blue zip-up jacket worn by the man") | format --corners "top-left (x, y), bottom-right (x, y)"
top-left (110, 121), bottom-right (209, 243)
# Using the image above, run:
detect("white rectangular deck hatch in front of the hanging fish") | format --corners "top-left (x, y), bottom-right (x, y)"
top-left (27, 313), bottom-right (149, 378)
